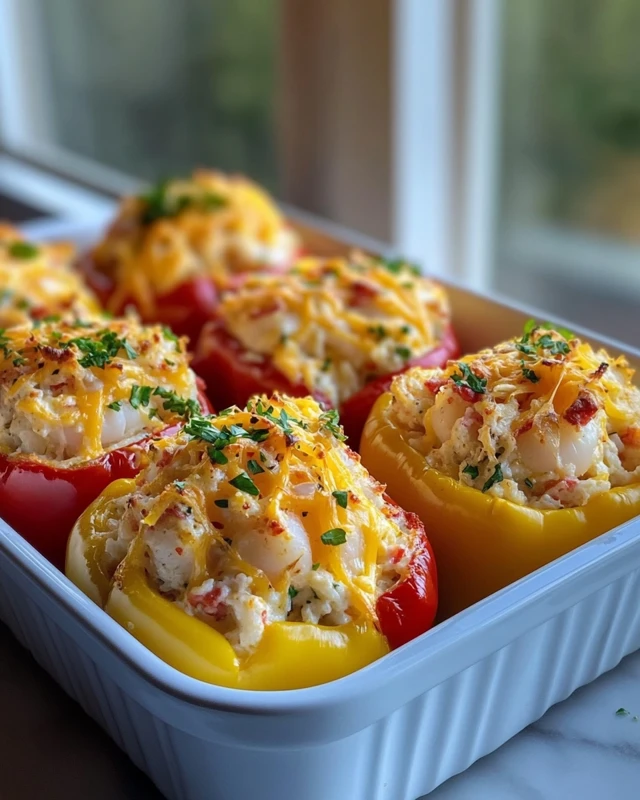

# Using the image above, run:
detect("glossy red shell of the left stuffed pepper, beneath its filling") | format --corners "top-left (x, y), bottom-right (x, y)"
top-left (0, 381), bottom-right (212, 570)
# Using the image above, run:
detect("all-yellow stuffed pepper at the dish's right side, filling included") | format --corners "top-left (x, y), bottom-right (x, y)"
top-left (362, 322), bottom-right (640, 617)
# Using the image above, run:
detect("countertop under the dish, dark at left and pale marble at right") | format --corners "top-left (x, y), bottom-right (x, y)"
top-left (0, 625), bottom-right (640, 800)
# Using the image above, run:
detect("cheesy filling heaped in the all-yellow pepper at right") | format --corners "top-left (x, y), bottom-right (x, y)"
top-left (390, 322), bottom-right (640, 508)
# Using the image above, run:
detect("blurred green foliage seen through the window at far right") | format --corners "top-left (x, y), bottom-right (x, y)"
top-left (501, 0), bottom-right (640, 227)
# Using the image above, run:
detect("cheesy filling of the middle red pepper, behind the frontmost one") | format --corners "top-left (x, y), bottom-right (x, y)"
top-left (218, 253), bottom-right (449, 406)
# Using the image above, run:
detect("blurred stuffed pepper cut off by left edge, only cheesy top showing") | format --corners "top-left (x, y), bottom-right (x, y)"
top-left (0, 223), bottom-right (100, 328)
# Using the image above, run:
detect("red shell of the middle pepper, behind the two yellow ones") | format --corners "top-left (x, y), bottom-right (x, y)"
top-left (191, 322), bottom-right (460, 447)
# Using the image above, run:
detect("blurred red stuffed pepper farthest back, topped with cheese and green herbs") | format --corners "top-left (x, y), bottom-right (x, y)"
top-left (81, 170), bottom-right (298, 344)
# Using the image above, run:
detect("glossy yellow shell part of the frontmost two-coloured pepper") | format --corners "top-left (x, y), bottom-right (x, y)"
top-left (66, 480), bottom-right (389, 690)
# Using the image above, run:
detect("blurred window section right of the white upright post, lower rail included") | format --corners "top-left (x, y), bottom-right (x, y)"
top-left (494, 0), bottom-right (640, 341)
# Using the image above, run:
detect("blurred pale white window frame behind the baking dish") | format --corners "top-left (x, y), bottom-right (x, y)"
top-left (0, 0), bottom-right (640, 306)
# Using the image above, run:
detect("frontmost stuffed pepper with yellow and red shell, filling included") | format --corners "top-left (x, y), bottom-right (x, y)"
top-left (66, 396), bottom-right (437, 689)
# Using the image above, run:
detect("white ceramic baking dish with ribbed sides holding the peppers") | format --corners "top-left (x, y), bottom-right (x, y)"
top-left (0, 219), bottom-right (640, 800)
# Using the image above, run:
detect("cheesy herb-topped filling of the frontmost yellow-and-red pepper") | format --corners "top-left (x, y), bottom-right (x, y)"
top-left (92, 396), bottom-right (415, 655)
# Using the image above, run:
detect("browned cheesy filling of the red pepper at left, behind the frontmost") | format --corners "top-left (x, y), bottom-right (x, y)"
top-left (0, 319), bottom-right (200, 462)
